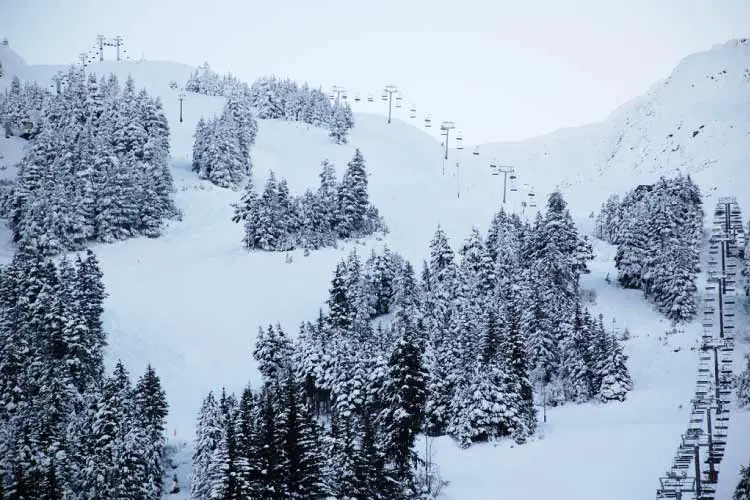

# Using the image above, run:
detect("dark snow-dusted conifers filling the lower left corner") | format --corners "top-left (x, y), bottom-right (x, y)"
top-left (0, 246), bottom-right (167, 500)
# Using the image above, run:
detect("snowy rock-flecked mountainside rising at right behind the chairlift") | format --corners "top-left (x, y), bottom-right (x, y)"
top-left (470, 39), bottom-right (750, 229)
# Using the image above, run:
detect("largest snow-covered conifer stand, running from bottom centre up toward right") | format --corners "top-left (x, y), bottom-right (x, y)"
top-left (194, 193), bottom-right (632, 499)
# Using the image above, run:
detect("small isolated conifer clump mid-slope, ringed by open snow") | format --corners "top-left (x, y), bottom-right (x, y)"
top-left (232, 149), bottom-right (387, 251)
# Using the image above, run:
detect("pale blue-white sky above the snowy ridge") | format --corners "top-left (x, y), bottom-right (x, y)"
top-left (0, 0), bottom-right (750, 143)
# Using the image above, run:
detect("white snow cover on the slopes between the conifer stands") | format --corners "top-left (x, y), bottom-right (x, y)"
top-left (0, 40), bottom-right (750, 500)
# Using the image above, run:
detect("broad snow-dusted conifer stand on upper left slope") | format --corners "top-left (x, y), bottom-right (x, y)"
top-left (2, 68), bottom-right (179, 255)
